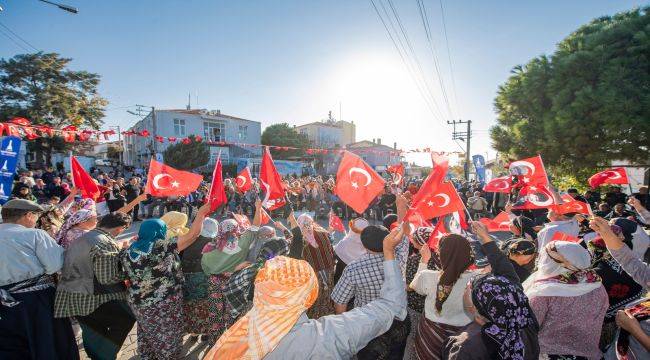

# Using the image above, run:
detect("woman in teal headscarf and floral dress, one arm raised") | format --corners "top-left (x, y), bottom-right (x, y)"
top-left (122, 204), bottom-right (210, 359)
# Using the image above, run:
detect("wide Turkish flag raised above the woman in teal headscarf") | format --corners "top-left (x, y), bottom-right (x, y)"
top-left (145, 159), bottom-right (203, 197)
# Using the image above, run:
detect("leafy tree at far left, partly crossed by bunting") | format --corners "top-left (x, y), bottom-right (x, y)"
top-left (0, 52), bottom-right (108, 165)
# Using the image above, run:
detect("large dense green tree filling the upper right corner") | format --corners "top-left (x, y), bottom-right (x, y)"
top-left (491, 7), bottom-right (650, 181)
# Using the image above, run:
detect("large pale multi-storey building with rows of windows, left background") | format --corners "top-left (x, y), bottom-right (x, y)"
top-left (124, 109), bottom-right (262, 167)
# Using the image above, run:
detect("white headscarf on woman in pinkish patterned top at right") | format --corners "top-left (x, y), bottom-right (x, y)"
top-left (523, 241), bottom-right (602, 298)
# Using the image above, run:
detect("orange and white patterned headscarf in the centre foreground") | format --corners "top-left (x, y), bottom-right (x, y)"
top-left (203, 256), bottom-right (318, 360)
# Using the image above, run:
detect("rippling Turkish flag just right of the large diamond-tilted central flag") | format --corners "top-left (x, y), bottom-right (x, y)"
top-left (407, 182), bottom-right (465, 221)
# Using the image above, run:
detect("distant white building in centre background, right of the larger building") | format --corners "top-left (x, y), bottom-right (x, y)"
top-left (296, 111), bottom-right (356, 149)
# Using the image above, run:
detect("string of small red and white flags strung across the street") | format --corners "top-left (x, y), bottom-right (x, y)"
top-left (0, 117), bottom-right (461, 156)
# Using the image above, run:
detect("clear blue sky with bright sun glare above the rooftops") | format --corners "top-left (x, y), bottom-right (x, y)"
top-left (0, 0), bottom-right (646, 164)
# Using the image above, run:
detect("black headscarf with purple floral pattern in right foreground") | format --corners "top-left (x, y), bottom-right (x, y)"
top-left (472, 275), bottom-right (539, 360)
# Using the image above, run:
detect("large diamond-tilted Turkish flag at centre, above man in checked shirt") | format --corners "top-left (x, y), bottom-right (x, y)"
top-left (334, 151), bottom-right (386, 214)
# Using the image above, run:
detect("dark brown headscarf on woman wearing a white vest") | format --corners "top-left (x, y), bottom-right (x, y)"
top-left (436, 234), bottom-right (474, 313)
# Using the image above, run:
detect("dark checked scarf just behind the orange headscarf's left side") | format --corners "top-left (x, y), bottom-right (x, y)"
top-left (224, 238), bottom-right (289, 318)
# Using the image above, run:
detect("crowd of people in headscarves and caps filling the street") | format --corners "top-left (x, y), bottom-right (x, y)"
top-left (0, 164), bottom-right (650, 360)
